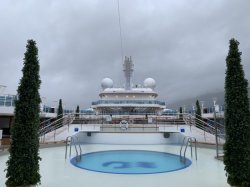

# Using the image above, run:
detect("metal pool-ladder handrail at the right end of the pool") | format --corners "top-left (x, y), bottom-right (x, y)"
top-left (180, 136), bottom-right (197, 163)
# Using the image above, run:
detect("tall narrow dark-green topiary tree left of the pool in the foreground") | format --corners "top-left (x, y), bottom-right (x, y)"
top-left (6, 40), bottom-right (41, 186)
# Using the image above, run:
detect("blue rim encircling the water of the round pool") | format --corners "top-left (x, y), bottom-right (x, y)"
top-left (70, 149), bottom-right (192, 175)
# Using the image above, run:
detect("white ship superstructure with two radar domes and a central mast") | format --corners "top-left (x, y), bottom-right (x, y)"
top-left (92, 57), bottom-right (166, 115)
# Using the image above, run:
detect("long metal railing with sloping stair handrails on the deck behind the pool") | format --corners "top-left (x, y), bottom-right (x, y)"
top-left (39, 113), bottom-right (224, 148)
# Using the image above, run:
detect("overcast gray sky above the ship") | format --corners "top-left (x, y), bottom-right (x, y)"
top-left (0, 0), bottom-right (250, 109)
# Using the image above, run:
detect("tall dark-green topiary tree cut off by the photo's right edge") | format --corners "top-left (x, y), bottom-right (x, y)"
top-left (224, 39), bottom-right (250, 187)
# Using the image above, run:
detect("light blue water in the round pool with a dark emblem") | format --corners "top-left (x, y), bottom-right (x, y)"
top-left (71, 150), bottom-right (192, 174)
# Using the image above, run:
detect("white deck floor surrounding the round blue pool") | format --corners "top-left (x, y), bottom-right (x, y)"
top-left (0, 144), bottom-right (229, 187)
